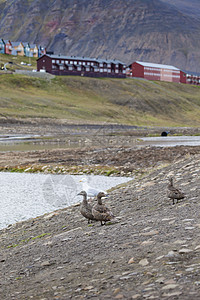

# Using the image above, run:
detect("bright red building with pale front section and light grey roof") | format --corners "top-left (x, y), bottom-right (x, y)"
top-left (127, 61), bottom-right (186, 83)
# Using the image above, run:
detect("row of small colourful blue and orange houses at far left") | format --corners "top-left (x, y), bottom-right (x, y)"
top-left (0, 39), bottom-right (46, 57)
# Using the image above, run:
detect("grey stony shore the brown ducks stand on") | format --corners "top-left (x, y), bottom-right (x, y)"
top-left (0, 147), bottom-right (200, 300)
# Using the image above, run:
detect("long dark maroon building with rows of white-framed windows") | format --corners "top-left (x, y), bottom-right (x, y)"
top-left (37, 54), bottom-right (126, 78)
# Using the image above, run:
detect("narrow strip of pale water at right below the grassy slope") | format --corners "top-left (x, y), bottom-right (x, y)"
top-left (139, 136), bottom-right (200, 147)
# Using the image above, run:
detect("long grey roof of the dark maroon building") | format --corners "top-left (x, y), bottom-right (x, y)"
top-left (40, 54), bottom-right (125, 65)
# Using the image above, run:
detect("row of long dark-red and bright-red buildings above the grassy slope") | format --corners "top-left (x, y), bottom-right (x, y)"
top-left (37, 54), bottom-right (200, 85)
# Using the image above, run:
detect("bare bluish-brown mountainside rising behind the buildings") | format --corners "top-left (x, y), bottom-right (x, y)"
top-left (0, 0), bottom-right (200, 72)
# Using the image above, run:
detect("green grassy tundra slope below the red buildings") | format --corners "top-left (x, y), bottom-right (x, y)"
top-left (0, 70), bottom-right (200, 126)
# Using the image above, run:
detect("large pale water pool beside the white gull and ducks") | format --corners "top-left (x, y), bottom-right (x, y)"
top-left (0, 173), bottom-right (131, 229)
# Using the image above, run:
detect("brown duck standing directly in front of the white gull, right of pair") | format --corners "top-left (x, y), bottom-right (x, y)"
top-left (92, 192), bottom-right (114, 225)
